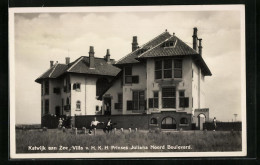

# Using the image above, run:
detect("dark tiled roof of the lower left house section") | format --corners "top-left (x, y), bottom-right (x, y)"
top-left (35, 56), bottom-right (120, 83)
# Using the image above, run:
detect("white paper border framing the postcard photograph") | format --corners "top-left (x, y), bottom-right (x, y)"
top-left (9, 5), bottom-right (247, 159)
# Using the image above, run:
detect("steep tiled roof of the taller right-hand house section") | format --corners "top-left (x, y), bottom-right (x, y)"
top-left (115, 31), bottom-right (212, 76)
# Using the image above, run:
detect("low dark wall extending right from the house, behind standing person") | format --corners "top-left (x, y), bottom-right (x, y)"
top-left (203, 122), bottom-right (242, 131)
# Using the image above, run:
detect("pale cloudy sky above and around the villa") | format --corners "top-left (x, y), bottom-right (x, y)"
top-left (14, 7), bottom-right (244, 124)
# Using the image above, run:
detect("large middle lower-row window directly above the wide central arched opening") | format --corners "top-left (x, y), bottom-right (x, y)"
top-left (162, 87), bottom-right (176, 108)
